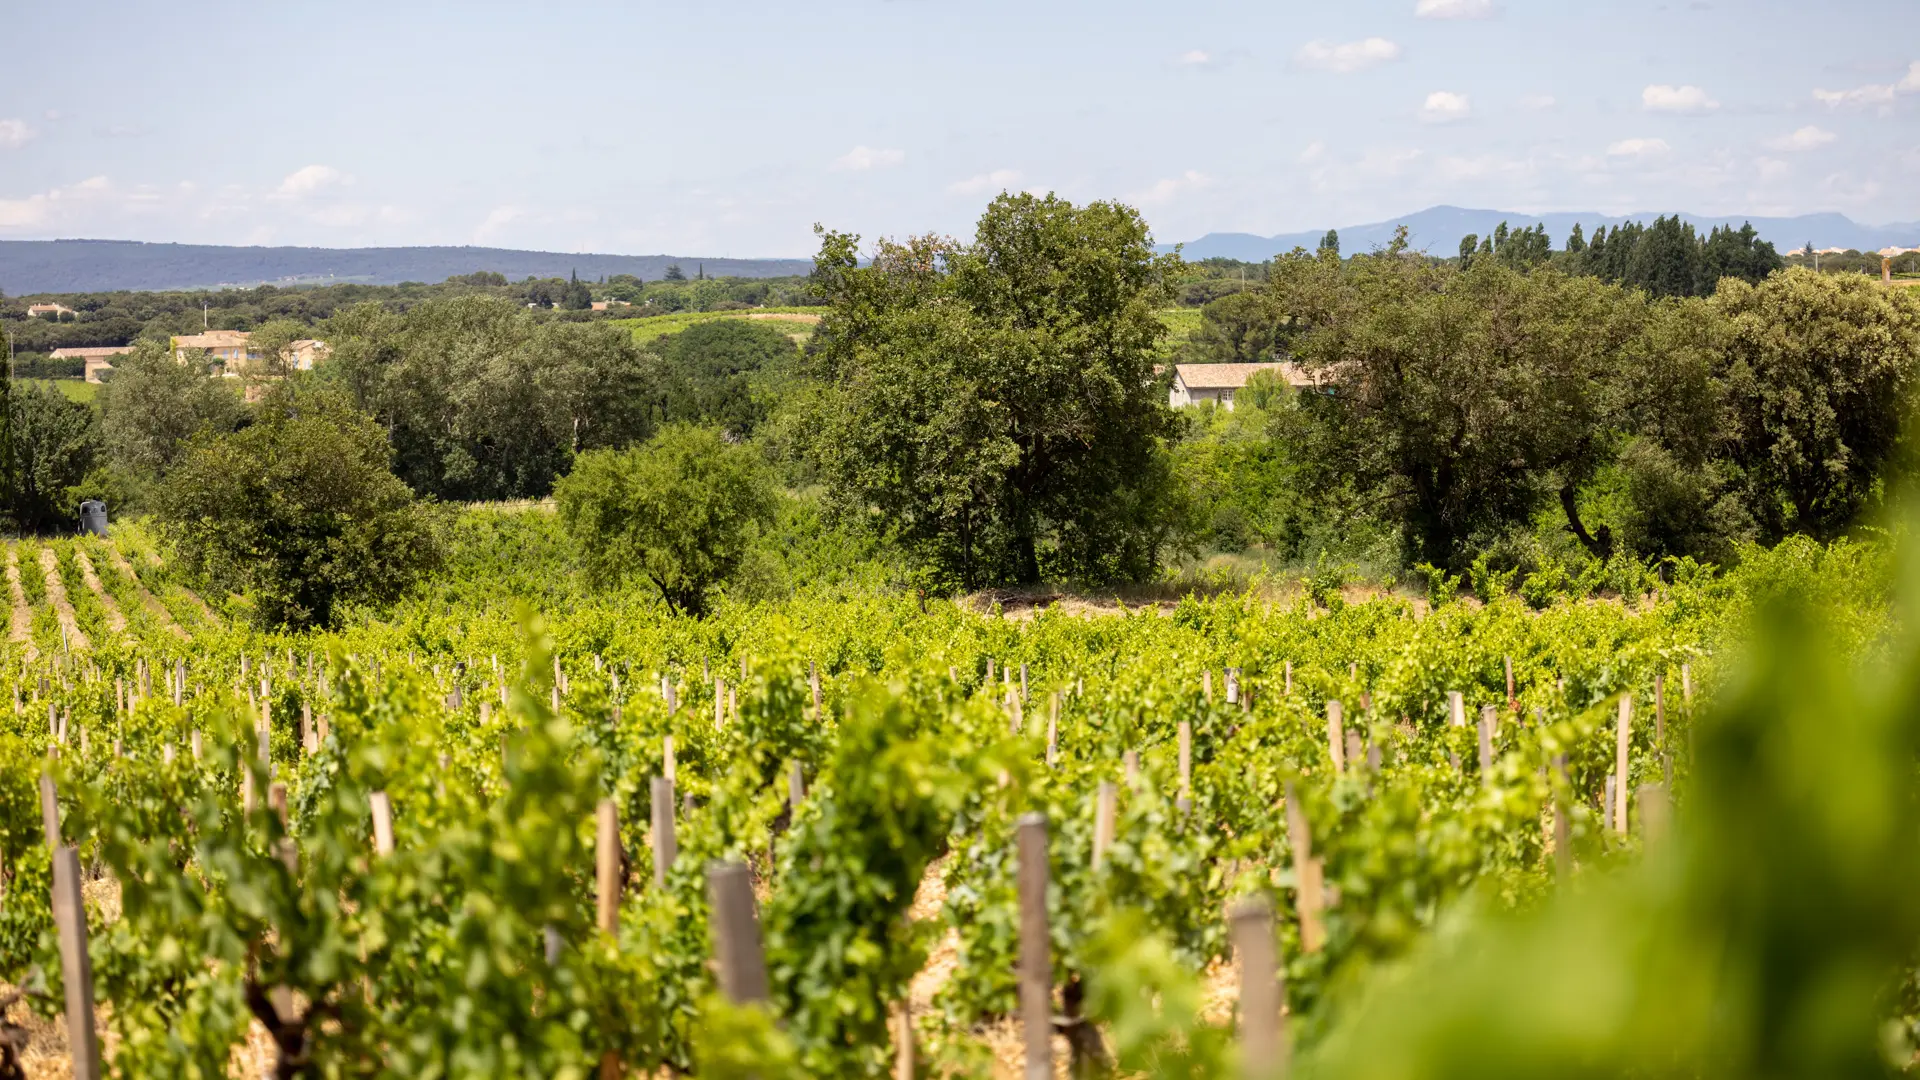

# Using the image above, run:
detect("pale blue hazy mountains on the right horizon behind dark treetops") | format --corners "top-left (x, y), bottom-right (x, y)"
top-left (1160, 206), bottom-right (1920, 263)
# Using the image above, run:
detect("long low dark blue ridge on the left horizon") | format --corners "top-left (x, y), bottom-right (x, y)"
top-left (0, 240), bottom-right (814, 296)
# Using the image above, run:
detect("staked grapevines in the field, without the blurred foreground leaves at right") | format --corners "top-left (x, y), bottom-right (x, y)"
top-left (0, 518), bottom-right (1872, 1078)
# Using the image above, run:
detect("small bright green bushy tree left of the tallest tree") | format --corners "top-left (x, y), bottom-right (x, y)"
top-left (553, 425), bottom-right (774, 615)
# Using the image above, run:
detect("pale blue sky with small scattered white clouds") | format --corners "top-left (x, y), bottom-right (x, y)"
top-left (0, 0), bottom-right (1920, 258)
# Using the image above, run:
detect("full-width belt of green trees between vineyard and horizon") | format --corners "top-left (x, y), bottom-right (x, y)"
top-left (0, 196), bottom-right (1920, 623)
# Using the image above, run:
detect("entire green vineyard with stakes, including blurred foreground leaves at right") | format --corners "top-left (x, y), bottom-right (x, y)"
top-left (0, 511), bottom-right (1916, 1080)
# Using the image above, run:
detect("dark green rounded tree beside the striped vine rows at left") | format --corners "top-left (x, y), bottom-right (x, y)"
top-left (159, 380), bottom-right (440, 628)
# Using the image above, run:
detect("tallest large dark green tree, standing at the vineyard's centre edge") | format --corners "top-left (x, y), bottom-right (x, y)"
top-left (810, 194), bottom-right (1177, 588)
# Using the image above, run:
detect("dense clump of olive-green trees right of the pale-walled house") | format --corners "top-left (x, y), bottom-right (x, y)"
top-left (1183, 238), bottom-right (1920, 569)
